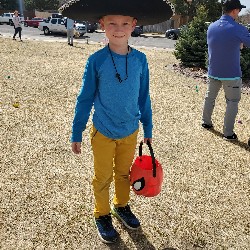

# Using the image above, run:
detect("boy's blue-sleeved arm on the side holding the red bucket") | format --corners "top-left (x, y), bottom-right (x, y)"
top-left (139, 57), bottom-right (153, 143)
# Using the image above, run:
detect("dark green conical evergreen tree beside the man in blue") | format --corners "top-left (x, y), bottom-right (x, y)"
top-left (174, 6), bottom-right (208, 68)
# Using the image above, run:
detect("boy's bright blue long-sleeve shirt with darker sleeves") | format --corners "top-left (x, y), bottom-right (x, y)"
top-left (71, 47), bottom-right (153, 142)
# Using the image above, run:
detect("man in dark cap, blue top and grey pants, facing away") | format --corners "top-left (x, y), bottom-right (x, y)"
top-left (202, 0), bottom-right (250, 140)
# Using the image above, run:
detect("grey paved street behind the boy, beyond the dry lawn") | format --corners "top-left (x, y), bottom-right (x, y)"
top-left (0, 24), bottom-right (176, 50)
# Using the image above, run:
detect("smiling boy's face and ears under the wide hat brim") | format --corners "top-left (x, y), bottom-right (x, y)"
top-left (100, 15), bottom-right (137, 43)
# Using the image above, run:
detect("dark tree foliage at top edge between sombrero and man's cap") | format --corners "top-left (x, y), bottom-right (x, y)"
top-left (170, 0), bottom-right (222, 22)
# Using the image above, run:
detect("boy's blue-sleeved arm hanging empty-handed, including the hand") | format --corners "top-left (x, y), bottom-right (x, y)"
top-left (71, 58), bottom-right (97, 146)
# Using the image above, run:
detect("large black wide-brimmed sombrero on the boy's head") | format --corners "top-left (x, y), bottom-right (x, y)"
top-left (59, 0), bottom-right (174, 25)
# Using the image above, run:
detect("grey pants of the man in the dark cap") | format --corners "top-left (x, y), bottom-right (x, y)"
top-left (202, 78), bottom-right (242, 136)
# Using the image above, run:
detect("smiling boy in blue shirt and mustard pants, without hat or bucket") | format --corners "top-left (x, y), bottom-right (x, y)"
top-left (71, 15), bottom-right (153, 243)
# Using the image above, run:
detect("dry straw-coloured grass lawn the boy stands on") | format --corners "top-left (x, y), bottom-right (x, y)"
top-left (0, 38), bottom-right (250, 250)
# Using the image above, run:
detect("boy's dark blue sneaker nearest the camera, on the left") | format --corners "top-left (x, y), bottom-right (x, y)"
top-left (94, 214), bottom-right (118, 243)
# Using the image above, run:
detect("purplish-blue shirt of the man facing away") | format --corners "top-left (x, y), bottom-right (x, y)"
top-left (207, 15), bottom-right (250, 80)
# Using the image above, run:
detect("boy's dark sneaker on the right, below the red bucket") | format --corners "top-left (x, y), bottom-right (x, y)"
top-left (111, 205), bottom-right (140, 230)
